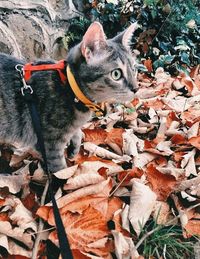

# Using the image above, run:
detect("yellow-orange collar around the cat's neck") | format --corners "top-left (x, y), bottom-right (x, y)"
top-left (66, 65), bottom-right (104, 117)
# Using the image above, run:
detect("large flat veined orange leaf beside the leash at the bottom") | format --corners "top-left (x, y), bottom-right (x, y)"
top-left (49, 206), bottom-right (112, 258)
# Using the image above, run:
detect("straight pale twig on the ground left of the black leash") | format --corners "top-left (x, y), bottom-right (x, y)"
top-left (31, 180), bottom-right (49, 259)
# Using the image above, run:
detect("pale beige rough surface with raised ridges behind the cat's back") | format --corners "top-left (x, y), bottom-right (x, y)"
top-left (0, 0), bottom-right (81, 61)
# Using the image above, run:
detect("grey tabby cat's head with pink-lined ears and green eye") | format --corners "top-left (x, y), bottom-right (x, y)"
top-left (68, 22), bottom-right (137, 102)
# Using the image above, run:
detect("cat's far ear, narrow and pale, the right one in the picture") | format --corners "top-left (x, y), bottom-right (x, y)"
top-left (112, 22), bottom-right (139, 49)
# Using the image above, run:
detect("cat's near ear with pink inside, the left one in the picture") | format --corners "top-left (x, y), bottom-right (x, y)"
top-left (81, 22), bottom-right (107, 62)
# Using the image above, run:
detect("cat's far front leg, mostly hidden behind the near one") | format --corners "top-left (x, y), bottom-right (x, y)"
top-left (67, 129), bottom-right (83, 158)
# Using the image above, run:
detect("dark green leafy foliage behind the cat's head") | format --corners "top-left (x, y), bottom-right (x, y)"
top-left (65, 0), bottom-right (200, 74)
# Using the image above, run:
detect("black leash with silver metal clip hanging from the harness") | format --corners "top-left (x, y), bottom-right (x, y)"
top-left (16, 65), bottom-right (73, 259)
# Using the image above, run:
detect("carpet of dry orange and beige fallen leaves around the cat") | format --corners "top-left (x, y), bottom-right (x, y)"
top-left (0, 64), bottom-right (200, 259)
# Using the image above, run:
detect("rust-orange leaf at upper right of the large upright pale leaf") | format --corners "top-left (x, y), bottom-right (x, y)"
top-left (146, 165), bottom-right (176, 201)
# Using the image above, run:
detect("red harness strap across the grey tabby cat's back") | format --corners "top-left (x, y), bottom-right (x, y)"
top-left (23, 60), bottom-right (67, 84)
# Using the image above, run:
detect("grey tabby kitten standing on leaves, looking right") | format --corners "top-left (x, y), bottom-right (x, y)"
top-left (0, 22), bottom-right (137, 172)
